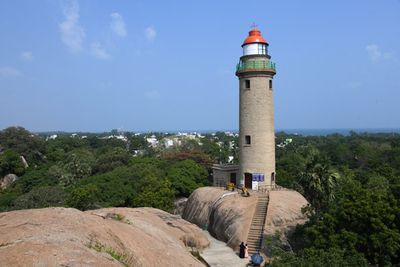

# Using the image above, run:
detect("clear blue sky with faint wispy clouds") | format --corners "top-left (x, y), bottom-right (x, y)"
top-left (0, 0), bottom-right (400, 131)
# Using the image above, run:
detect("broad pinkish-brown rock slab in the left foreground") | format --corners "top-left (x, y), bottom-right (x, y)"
top-left (0, 208), bottom-right (209, 267)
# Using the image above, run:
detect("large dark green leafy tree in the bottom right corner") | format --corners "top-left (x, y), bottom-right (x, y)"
top-left (294, 177), bottom-right (400, 266)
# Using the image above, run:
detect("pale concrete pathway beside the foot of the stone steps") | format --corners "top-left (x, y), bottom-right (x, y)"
top-left (200, 231), bottom-right (249, 267)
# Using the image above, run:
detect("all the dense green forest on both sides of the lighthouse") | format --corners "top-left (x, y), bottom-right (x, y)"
top-left (0, 127), bottom-right (400, 266)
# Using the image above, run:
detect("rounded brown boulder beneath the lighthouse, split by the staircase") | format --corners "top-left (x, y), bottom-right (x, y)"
top-left (182, 187), bottom-right (307, 253)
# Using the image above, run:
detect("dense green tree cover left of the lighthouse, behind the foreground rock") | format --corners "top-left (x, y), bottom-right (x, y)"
top-left (0, 127), bottom-right (220, 214)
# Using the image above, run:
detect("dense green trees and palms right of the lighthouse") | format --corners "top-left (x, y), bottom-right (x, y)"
top-left (270, 133), bottom-right (400, 266)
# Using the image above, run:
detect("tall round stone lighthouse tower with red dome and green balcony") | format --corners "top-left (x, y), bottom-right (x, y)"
top-left (236, 27), bottom-right (276, 190)
